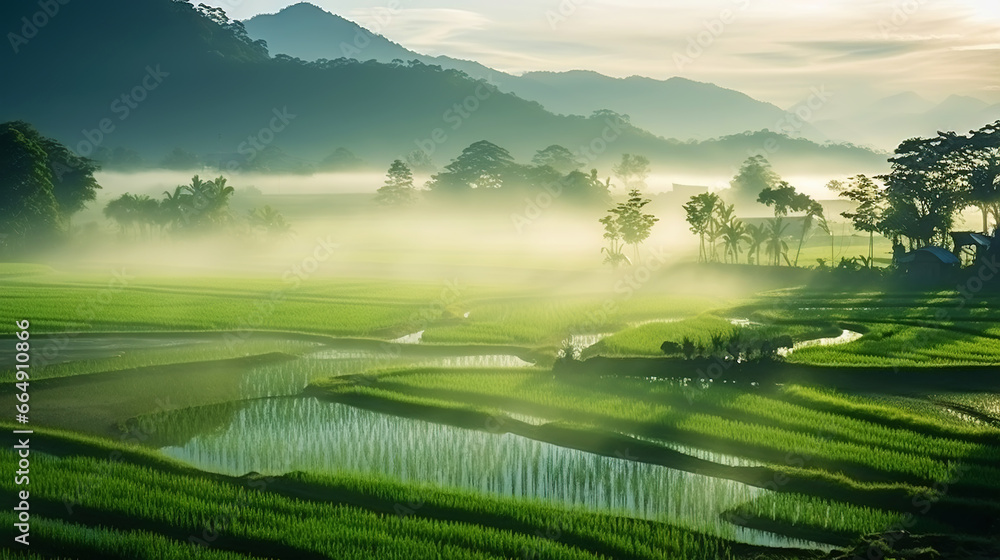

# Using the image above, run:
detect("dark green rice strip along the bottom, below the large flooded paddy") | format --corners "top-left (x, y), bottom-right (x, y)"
top-left (0, 424), bottom-right (752, 560)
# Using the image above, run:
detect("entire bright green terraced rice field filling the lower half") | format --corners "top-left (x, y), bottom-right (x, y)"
top-left (0, 253), bottom-right (1000, 558)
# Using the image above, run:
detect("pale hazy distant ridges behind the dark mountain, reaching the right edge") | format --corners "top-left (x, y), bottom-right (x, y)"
top-left (244, 2), bottom-right (1000, 150)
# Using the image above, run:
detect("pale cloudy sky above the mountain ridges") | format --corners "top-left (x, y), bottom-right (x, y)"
top-left (199, 0), bottom-right (1000, 107)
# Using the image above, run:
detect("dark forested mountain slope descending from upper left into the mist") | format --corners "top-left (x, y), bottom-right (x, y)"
top-left (0, 0), bottom-right (885, 174)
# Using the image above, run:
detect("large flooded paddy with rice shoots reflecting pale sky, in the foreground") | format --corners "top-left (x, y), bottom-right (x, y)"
top-left (157, 398), bottom-right (828, 547)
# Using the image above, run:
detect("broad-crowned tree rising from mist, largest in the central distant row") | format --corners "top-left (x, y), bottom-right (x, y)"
top-left (428, 140), bottom-right (516, 193)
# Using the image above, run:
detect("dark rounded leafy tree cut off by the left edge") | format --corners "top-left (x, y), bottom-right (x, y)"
top-left (0, 127), bottom-right (60, 243)
